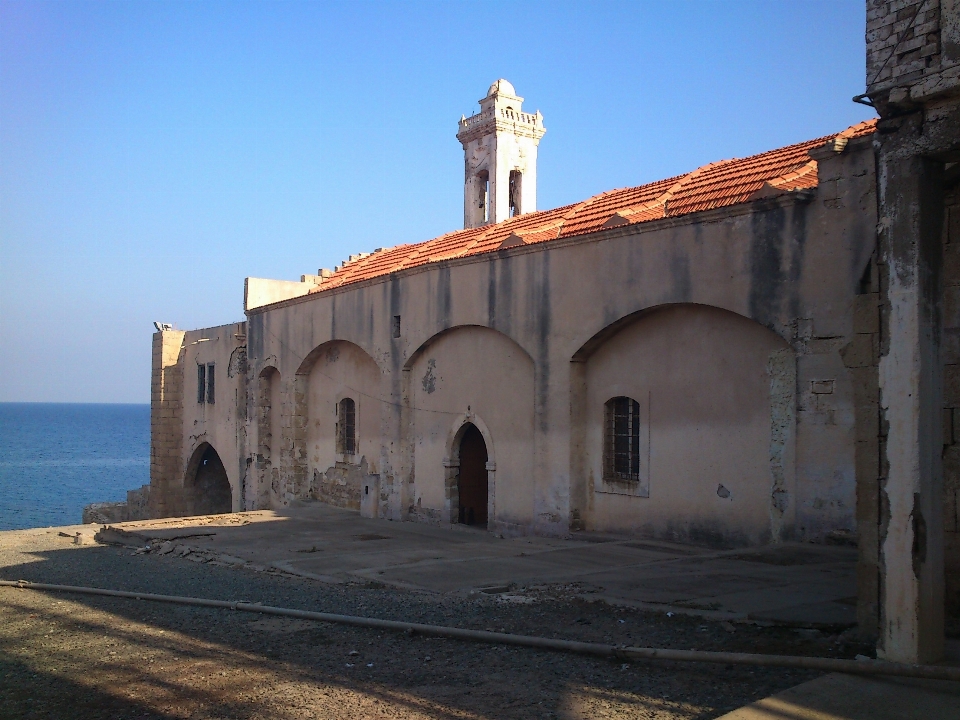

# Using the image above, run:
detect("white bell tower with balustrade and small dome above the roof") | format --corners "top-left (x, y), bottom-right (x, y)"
top-left (457, 80), bottom-right (546, 228)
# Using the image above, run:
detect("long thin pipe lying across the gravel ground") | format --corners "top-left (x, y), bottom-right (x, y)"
top-left (0, 580), bottom-right (960, 682)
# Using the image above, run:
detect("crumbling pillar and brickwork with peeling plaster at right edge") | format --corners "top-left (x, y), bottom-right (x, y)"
top-left (858, 0), bottom-right (960, 662)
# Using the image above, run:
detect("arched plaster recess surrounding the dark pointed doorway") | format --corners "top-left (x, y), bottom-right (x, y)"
top-left (402, 325), bottom-right (535, 528)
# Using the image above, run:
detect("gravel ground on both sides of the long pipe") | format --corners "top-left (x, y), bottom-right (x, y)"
top-left (0, 530), bottom-right (871, 720)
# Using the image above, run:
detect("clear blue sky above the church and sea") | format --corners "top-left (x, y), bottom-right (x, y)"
top-left (0, 0), bottom-right (871, 402)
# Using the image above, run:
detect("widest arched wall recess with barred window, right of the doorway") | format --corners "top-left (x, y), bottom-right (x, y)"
top-left (571, 303), bottom-right (796, 546)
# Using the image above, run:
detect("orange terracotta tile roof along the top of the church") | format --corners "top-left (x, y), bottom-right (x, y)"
top-left (312, 120), bottom-right (876, 292)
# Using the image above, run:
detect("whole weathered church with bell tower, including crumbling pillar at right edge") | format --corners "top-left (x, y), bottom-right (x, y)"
top-left (150, 0), bottom-right (960, 660)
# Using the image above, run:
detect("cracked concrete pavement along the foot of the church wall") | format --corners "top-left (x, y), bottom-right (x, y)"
top-left (90, 503), bottom-right (856, 629)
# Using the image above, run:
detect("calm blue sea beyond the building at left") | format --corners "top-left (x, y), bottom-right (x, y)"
top-left (0, 403), bottom-right (150, 530)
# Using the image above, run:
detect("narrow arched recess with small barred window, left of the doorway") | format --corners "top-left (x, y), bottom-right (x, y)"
top-left (291, 340), bottom-right (381, 507)
